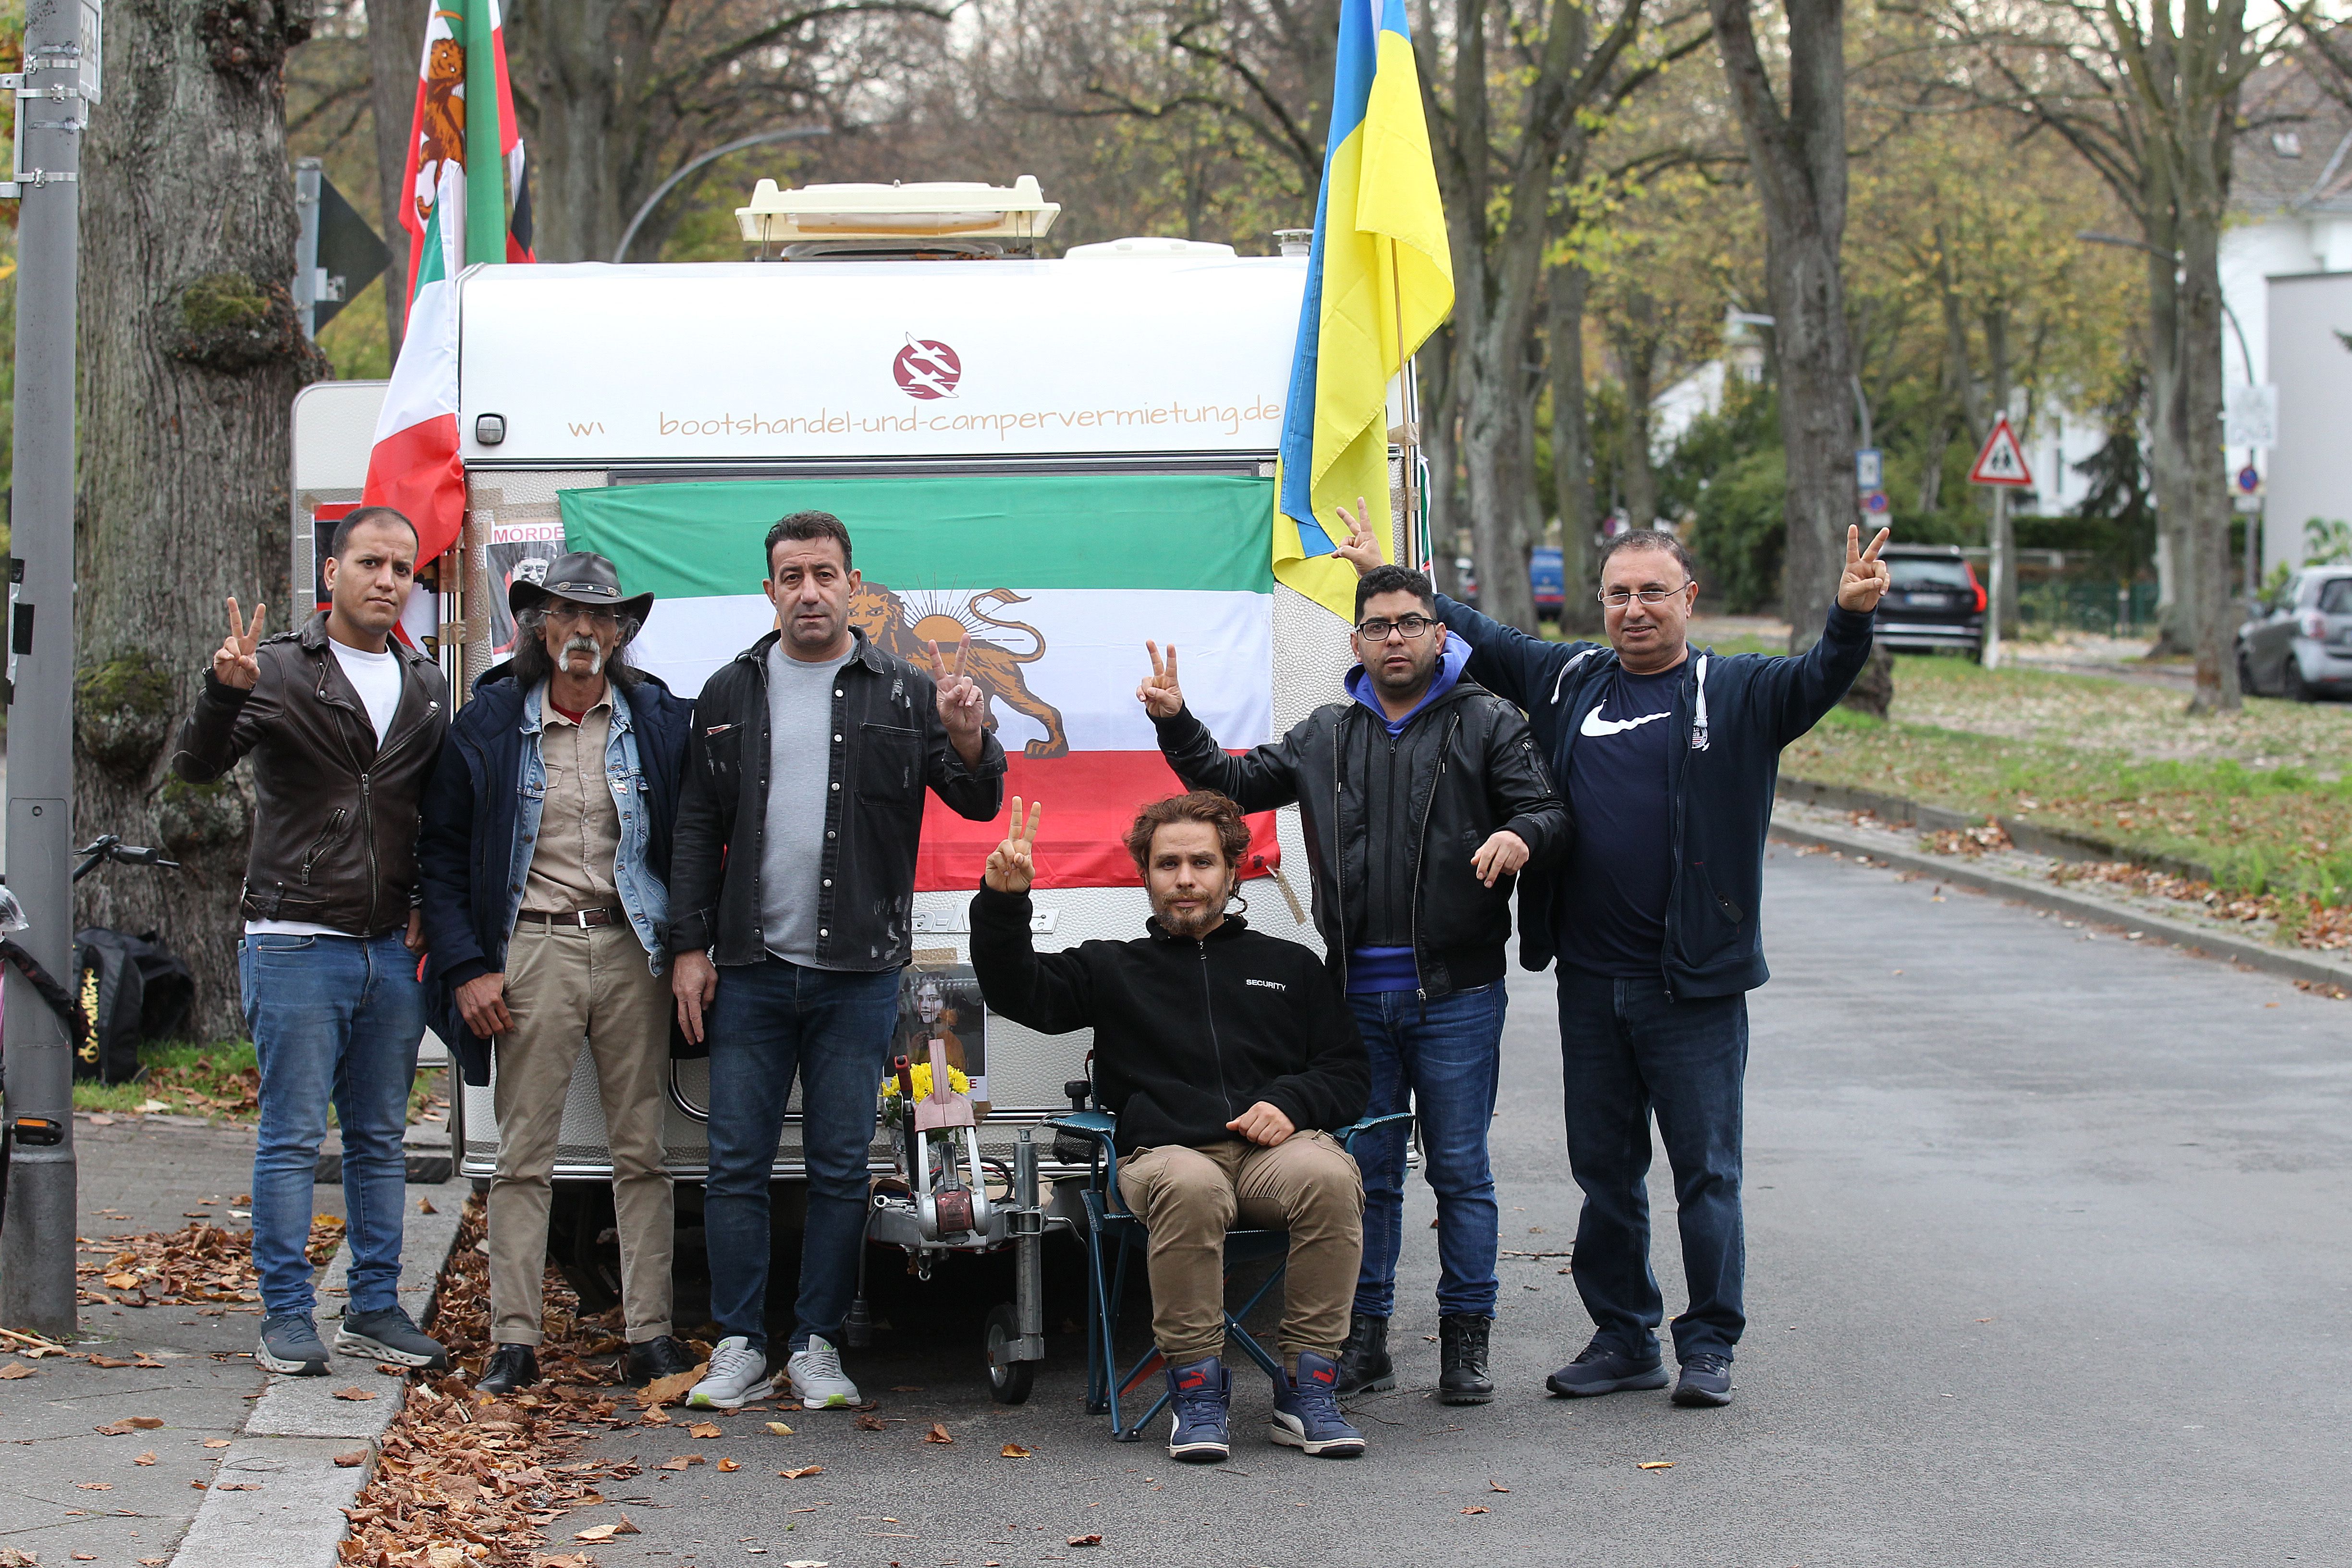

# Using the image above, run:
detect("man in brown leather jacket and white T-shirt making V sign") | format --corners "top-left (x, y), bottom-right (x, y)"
top-left (172, 505), bottom-right (449, 1378)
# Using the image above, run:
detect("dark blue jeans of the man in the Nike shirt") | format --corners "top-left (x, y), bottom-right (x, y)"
top-left (1559, 964), bottom-right (1748, 1361)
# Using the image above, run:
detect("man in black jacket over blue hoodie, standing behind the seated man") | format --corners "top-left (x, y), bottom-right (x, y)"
top-left (1136, 566), bottom-right (1567, 1403)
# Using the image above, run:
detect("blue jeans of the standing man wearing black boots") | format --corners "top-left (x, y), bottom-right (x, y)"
top-left (1348, 980), bottom-right (1507, 1316)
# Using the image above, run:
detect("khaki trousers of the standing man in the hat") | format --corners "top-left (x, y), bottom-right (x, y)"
top-left (489, 919), bottom-right (670, 1345)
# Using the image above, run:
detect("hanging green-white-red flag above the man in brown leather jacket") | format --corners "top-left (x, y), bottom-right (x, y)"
top-left (362, 0), bottom-right (534, 562)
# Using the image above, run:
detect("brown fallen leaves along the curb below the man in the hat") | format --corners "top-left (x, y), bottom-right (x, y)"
top-left (339, 1197), bottom-right (668, 1568)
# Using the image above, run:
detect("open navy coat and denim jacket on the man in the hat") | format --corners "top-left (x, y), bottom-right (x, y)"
top-left (416, 663), bottom-right (694, 1084)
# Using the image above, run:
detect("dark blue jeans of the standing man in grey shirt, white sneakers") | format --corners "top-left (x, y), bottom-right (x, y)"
top-left (703, 957), bottom-right (898, 1349)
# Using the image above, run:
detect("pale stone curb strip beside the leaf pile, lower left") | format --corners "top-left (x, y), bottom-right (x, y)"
top-left (172, 1180), bottom-right (470, 1568)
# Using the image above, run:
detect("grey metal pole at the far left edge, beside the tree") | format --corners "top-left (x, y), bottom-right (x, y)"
top-left (0, 0), bottom-right (97, 1337)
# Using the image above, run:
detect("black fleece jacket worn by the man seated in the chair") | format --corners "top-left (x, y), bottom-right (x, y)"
top-left (971, 886), bottom-right (1371, 1154)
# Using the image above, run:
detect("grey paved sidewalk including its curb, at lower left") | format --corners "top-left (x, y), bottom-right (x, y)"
top-left (0, 1048), bottom-right (466, 1568)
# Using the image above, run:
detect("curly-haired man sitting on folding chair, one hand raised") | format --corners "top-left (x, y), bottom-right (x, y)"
top-left (971, 790), bottom-right (1371, 1462)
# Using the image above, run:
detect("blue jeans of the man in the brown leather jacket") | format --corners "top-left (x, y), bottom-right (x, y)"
top-left (237, 931), bottom-right (426, 1316)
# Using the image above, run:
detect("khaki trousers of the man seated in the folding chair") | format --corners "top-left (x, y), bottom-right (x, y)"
top-left (1119, 1133), bottom-right (1364, 1366)
